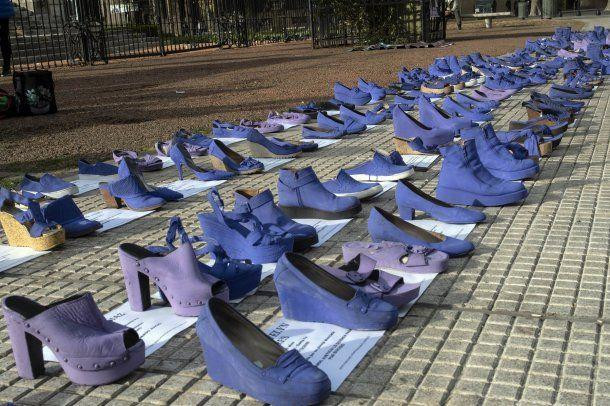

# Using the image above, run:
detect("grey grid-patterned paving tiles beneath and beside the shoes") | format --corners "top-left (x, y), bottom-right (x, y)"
top-left (0, 77), bottom-right (610, 406)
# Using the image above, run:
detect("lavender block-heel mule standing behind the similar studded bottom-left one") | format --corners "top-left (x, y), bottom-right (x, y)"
top-left (119, 241), bottom-right (229, 317)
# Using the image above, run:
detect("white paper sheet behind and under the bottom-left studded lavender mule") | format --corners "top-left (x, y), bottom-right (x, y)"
top-left (43, 303), bottom-right (197, 361)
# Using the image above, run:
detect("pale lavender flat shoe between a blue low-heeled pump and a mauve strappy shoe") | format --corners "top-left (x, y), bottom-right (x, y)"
top-left (343, 241), bottom-right (449, 275)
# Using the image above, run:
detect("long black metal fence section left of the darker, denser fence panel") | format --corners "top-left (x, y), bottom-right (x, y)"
top-left (10, 0), bottom-right (310, 69)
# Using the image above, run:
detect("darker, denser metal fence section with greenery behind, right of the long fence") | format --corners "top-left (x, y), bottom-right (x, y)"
top-left (311, 0), bottom-right (445, 48)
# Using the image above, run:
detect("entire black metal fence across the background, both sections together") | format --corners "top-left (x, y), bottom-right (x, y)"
top-left (3, 0), bottom-right (445, 70)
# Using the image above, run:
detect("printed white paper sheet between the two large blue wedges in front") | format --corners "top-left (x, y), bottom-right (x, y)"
top-left (266, 319), bottom-right (384, 390)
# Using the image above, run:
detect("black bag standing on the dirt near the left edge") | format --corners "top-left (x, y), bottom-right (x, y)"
top-left (13, 70), bottom-right (57, 116)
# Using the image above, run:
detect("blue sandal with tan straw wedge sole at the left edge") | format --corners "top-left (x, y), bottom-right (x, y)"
top-left (0, 188), bottom-right (66, 251)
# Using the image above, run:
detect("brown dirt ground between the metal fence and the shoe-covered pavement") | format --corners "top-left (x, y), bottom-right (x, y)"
top-left (0, 19), bottom-right (580, 178)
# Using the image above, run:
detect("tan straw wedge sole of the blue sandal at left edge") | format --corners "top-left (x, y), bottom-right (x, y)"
top-left (0, 211), bottom-right (66, 251)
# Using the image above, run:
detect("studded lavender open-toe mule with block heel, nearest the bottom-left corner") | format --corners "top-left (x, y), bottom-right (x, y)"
top-left (2, 293), bottom-right (144, 385)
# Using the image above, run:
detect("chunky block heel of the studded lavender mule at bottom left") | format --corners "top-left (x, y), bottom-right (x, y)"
top-left (6, 317), bottom-right (44, 379)
